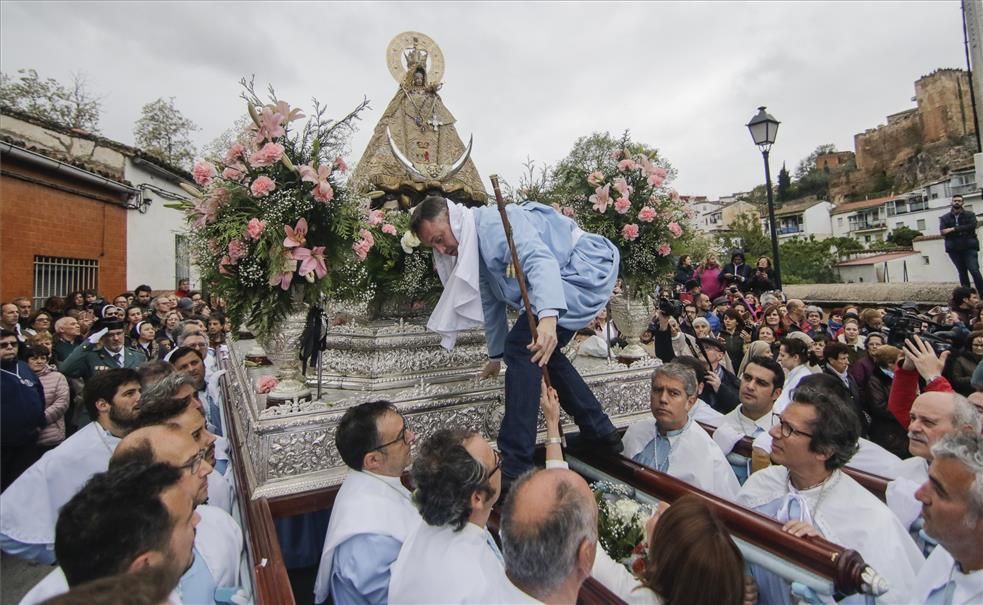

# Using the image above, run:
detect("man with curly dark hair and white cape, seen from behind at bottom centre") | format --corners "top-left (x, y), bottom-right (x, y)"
top-left (389, 429), bottom-right (514, 605)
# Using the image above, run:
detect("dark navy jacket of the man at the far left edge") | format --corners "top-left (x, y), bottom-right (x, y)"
top-left (0, 360), bottom-right (47, 448)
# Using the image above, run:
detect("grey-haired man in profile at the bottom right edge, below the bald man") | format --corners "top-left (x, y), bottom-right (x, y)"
top-left (911, 431), bottom-right (983, 605)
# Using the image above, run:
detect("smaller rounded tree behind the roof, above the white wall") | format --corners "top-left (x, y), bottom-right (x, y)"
top-left (133, 97), bottom-right (198, 169)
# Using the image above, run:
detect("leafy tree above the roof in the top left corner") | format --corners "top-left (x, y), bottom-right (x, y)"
top-left (0, 69), bottom-right (102, 133)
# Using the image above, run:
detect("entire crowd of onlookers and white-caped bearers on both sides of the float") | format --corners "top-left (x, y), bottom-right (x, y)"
top-left (0, 253), bottom-right (983, 605)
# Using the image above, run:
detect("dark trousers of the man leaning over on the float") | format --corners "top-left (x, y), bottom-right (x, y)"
top-left (498, 313), bottom-right (614, 478)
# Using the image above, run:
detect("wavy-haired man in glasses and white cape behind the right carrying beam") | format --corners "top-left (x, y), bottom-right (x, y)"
top-left (737, 374), bottom-right (924, 603)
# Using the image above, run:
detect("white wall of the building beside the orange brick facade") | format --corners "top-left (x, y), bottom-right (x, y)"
top-left (125, 158), bottom-right (201, 290)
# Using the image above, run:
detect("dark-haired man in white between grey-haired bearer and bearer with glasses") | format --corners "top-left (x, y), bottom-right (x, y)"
top-left (713, 356), bottom-right (785, 485)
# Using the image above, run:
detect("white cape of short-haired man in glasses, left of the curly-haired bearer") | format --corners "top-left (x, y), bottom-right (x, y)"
top-left (314, 471), bottom-right (421, 603)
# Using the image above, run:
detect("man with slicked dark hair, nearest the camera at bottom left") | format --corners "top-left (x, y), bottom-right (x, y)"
top-left (21, 463), bottom-right (199, 605)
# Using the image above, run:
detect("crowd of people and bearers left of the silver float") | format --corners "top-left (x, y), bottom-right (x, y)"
top-left (0, 282), bottom-right (241, 604)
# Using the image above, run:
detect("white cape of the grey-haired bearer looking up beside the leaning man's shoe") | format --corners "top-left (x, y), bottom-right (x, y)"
top-left (621, 418), bottom-right (741, 500)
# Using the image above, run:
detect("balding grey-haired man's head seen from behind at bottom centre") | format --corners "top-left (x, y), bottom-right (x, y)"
top-left (502, 468), bottom-right (597, 603)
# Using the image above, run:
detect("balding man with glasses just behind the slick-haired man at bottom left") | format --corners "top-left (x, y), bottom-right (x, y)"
top-left (109, 424), bottom-right (243, 603)
